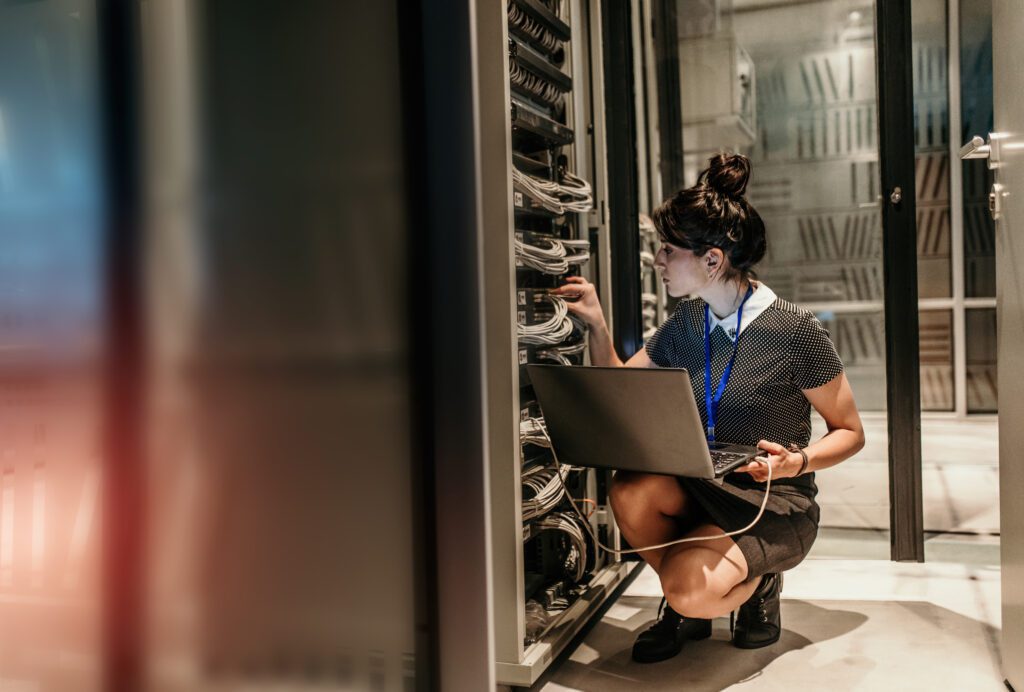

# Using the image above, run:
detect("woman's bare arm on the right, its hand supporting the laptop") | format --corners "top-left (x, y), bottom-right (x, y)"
top-left (736, 373), bottom-right (864, 482)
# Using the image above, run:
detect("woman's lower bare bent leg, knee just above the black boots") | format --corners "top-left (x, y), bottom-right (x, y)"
top-left (658, 524), bottom-right (759, 618)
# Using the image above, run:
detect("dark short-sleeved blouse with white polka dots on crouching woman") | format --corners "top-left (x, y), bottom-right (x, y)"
top-left (645, 298), bottom-right (843, 493)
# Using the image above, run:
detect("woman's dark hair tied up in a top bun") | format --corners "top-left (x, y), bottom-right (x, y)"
top-left (651, 154), bottom-right (765, 279)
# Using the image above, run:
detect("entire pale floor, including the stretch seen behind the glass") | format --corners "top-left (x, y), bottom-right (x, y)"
top-left (531, 416), bottom-right (1006, 692)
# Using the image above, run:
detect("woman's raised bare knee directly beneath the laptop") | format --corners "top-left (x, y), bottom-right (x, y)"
top-left (609, 471), bottom-right (697, 571)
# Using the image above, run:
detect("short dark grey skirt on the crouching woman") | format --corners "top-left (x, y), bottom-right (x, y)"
top-left (679, 478), bottom-right (819, 579)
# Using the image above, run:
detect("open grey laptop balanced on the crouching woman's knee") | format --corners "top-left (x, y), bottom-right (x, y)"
top-left (527, 364), bottom-right (765, 478)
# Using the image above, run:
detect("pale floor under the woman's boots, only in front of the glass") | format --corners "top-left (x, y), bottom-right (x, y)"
top-left (534, 531), bottom-right (1005, 692)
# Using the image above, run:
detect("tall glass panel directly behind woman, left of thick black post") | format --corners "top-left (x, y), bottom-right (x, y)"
top-left (663, 0), bottom-right (890, 559)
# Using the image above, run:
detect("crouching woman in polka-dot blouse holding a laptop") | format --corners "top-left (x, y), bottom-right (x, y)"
top-left (554, 155), bottom-right (864, 662)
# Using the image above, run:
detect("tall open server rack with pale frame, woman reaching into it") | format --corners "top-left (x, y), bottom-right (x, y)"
top-left (477, 0), bottom-right (637, 686)
